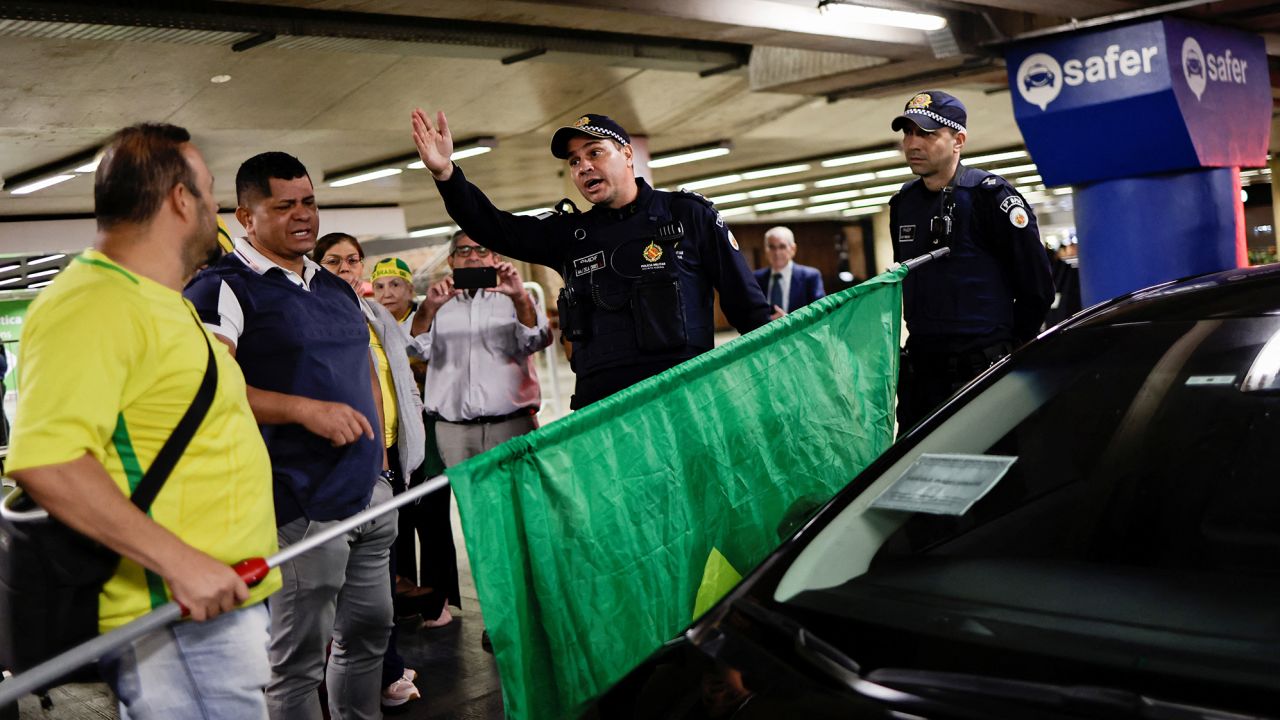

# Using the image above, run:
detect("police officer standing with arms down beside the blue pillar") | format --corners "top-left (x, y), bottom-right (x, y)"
top-left (890, 90), bottom-right (1053, 430)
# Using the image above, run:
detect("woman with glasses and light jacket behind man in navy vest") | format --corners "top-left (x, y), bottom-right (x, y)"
top-left (311, 233), bottom-right (426, 706)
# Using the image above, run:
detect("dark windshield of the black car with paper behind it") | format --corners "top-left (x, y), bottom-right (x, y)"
top-left (773, 316), bottom-right (1280, 692)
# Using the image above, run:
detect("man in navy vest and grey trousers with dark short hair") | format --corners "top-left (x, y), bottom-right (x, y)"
top-left (186, 152), bottom-right (396, 720)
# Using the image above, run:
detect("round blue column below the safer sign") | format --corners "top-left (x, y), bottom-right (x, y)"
top-left (1075, 168), bottom-right (1242, 306)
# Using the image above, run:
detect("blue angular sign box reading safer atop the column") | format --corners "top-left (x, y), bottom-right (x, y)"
top-left (1006, 18), bottom-right (1271, 184)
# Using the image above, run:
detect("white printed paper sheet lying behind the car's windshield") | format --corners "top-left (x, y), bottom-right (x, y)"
top-left (872, 454), bottom-right (1018, 515)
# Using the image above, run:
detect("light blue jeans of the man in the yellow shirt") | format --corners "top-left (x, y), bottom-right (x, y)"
top-left (102, 602), bottom-right (271, 720)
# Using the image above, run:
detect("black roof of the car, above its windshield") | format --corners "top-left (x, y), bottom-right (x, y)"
top-left (1064, 264), bottom-right (1280, 329)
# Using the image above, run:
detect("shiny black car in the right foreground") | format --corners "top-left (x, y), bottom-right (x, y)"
top-left (586, 266), bottom-right (1280, 720)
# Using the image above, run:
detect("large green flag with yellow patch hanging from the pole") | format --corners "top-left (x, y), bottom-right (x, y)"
top-left (448, 268), bottom-right (906, 720)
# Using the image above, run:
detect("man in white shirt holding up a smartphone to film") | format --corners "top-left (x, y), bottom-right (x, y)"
top-left (412, 231), bottom-right (552, 466)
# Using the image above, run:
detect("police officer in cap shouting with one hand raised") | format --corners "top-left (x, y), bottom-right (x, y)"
top-left (413, 110), bottom-right (772, 409)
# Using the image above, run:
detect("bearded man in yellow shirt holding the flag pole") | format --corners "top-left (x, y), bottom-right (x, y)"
top-left (9, 124), bottom-right (280, 720)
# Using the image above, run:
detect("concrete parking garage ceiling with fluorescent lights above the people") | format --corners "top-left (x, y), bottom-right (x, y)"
top-left (0, 0), bottom-right (1280, 238)
